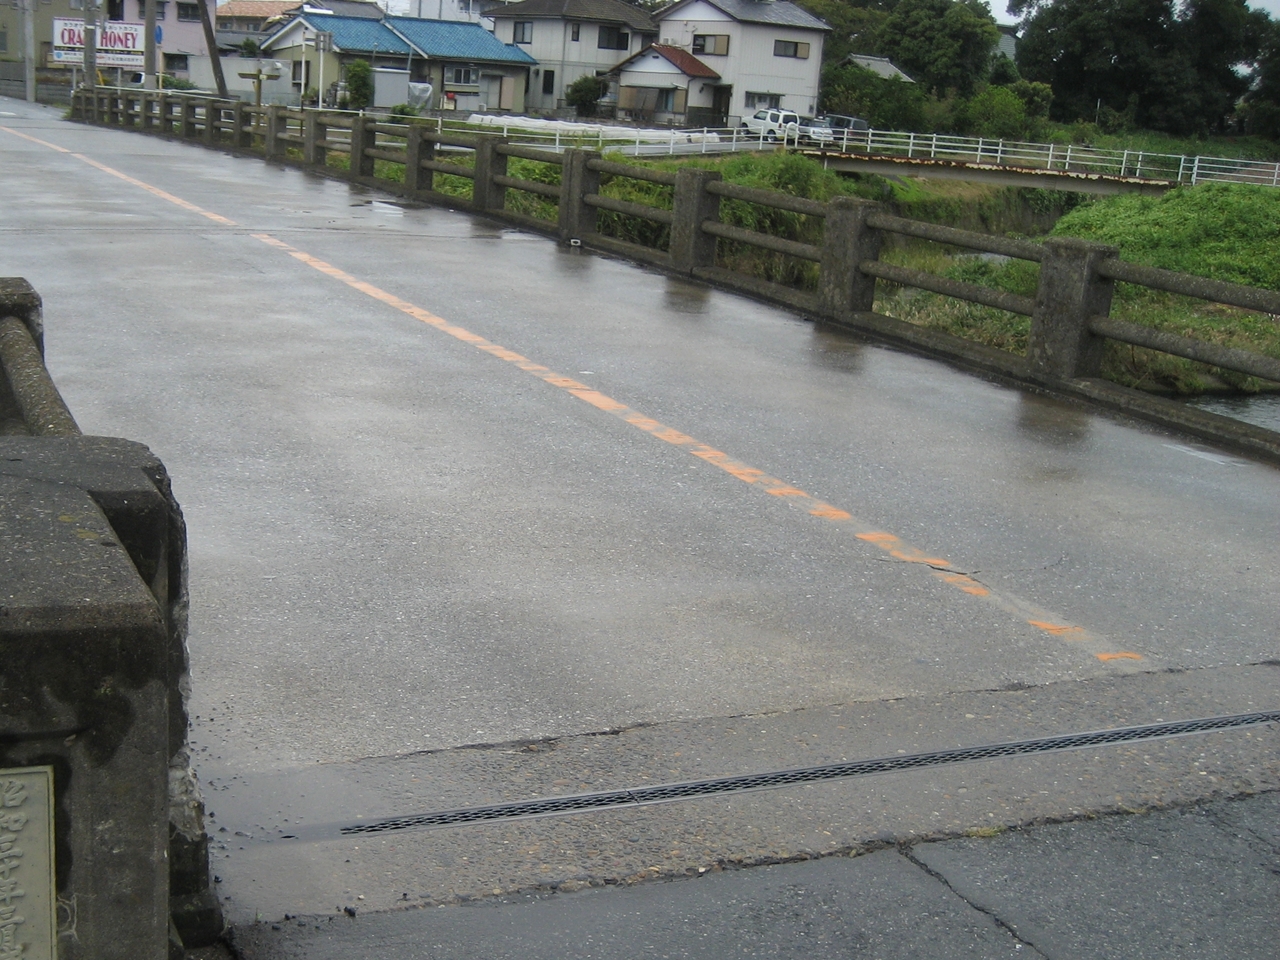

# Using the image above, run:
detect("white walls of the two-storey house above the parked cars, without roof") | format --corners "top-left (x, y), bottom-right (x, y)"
top-left (658, 3), bottom-right (824, 116)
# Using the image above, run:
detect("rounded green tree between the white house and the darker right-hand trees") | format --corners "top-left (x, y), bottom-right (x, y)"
top-left (879, 0), bottom-right (1000, 96)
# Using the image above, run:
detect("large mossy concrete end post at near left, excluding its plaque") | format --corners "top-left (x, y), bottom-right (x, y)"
top-left (0, 436), bottom-right (207, 960)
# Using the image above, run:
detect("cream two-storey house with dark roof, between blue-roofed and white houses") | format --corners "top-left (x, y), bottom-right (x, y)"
top-left (483, 0), bottom-right (658, 111)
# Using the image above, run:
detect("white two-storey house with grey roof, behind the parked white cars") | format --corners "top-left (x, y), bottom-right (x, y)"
top-left (650, 0), bottom-right (831, 125)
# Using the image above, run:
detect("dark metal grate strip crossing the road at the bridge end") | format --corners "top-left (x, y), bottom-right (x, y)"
top-left (339, 710), bottom-right (1280, 836)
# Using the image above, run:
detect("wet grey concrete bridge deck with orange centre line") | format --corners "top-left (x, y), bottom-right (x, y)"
top-left (0, 100), bottom-right (1280, 956)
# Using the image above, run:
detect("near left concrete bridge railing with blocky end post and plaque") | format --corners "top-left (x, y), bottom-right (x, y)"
top-left (0, 278), bottom-right (221, 960)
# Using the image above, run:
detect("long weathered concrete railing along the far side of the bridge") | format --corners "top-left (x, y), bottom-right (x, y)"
top-left (74, 92), bottom-right (1280, 460)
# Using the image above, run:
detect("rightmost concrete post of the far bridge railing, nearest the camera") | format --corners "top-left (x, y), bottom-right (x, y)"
top-left (1027, 237), bottom-right (1120, 380)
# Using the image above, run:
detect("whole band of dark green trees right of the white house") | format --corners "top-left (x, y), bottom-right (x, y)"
top-left (796, 0), bottom-right (1280, 140)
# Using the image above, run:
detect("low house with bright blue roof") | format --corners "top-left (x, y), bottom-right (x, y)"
top-left (262, 9), bottom-right (536, 113)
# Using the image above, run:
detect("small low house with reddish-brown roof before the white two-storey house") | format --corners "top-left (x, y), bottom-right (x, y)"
top-left (609, 44), bottom-right (723, 127)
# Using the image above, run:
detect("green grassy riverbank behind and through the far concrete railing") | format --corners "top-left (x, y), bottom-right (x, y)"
top-left (332, 143), bottom-right (1280, 394)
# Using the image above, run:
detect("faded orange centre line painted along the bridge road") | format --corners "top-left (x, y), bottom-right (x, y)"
top-left (0, 127), bottom-right (1143, 664)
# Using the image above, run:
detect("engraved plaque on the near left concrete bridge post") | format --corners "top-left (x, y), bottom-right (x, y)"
top-left (0, 767), bottom-right (58, 960)
